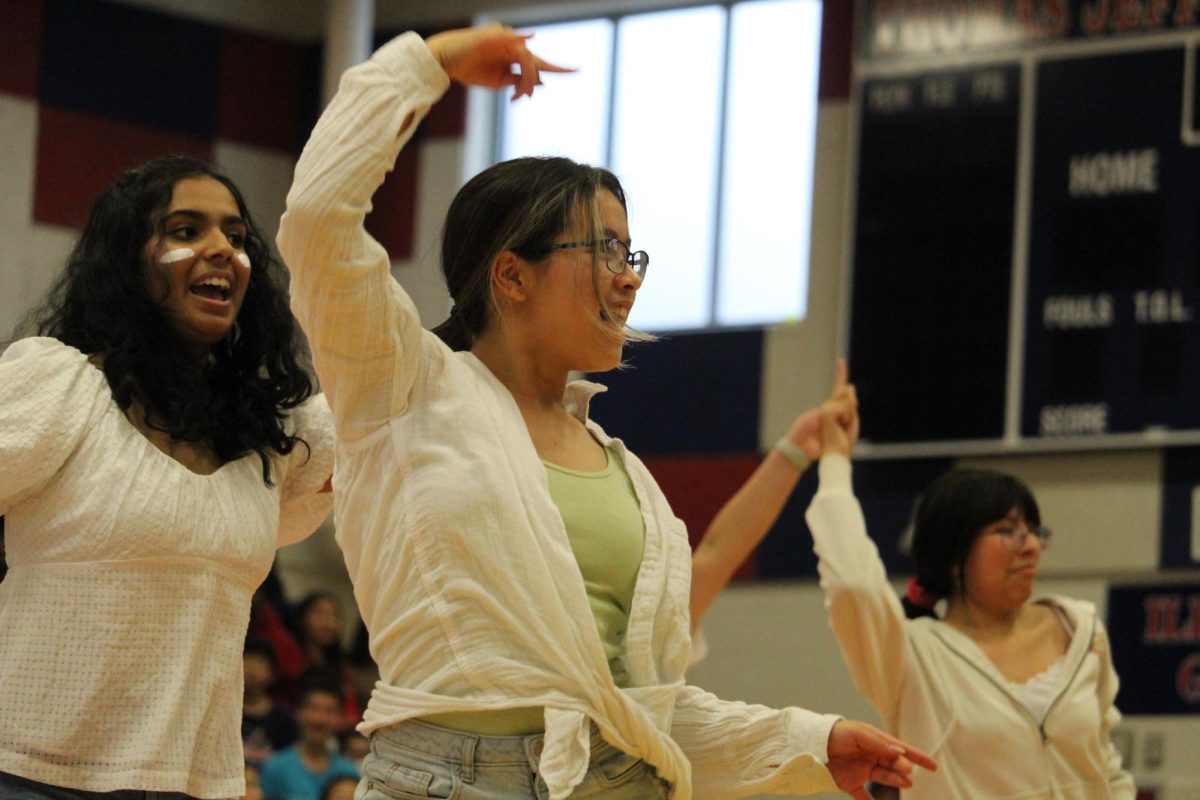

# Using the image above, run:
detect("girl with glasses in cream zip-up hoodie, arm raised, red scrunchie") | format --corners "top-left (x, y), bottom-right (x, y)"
top-left (806, 402), bottom-right (1135, 800)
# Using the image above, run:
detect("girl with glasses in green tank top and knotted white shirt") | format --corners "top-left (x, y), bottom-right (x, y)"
top-left (278, 26), bottom-right (931, 800)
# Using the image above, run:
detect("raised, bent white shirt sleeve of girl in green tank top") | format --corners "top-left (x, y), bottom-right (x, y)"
top-left (277, 34), bottom-right (450, 441)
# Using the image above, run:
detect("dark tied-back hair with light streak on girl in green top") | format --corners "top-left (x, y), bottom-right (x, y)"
top-left (433, 157), bottom-right (625, 350)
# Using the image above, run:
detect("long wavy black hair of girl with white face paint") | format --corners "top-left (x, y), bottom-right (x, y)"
top-left (20, 156), bottom-right (313, 486)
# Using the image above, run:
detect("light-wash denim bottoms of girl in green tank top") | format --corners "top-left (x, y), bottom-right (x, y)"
top-left (354, 720), bottom-right (671, 800)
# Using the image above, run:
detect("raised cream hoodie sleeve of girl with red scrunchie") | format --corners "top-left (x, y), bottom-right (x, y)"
top-left (805, 455), bottom-right (908, 730)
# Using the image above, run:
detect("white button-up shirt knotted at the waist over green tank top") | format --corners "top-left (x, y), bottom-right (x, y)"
top-left (278, 34), bottom-right (836, 800)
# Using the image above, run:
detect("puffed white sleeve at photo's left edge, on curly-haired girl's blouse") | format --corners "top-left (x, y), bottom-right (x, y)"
top-left (0, 337), bottom-right (112, 515)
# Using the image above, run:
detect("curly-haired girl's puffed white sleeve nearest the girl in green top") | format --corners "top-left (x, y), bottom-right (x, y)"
top-left (278, 395), bottom-right (334, 547)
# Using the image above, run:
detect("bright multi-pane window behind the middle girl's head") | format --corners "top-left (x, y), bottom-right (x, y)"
top-left (496, 0), bottom-right (821, 331)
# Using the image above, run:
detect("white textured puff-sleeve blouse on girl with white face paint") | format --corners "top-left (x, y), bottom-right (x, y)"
top-left (0, 338), bottom-right (332, 798)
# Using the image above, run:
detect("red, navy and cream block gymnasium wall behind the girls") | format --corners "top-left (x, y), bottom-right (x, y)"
top-left (0, 0), bottom-right (1200, 800)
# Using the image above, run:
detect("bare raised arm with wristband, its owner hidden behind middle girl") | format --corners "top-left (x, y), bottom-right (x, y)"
top-left (691, 360), bottom-right (858, 630)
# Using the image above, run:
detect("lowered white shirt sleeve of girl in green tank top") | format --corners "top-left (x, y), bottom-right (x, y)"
top-left (671, 686), bottom-right (841, 800)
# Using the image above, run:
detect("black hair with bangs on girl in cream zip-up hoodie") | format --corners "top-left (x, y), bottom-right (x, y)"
top-left (904, 469), bottom-right (1042, 618)
